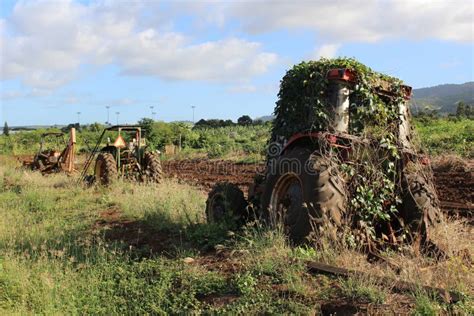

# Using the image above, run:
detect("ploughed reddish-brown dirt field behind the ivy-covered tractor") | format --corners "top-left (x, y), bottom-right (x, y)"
top-left (163, 159), bottom-right (474, 215)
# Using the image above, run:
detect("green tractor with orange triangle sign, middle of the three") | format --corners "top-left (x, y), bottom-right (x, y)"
top-left (81, 125), bottom-right (162, 185)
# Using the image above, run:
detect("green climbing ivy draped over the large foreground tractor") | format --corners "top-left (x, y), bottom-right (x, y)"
top-left (270, 58), bottom-right (412, 244)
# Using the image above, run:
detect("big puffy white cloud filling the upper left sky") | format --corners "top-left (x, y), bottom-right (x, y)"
top-left (0, 1), bottom-right (277, 90)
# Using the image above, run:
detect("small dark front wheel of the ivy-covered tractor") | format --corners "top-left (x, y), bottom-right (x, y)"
top-left (206, 182), bottom-right (248, 226)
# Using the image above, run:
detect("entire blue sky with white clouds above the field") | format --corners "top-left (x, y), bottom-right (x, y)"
top-left (0, 0), bottom-right (474, 126)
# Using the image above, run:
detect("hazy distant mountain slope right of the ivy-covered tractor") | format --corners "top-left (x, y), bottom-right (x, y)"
top-left (411, 82), bottom-right (474, 113)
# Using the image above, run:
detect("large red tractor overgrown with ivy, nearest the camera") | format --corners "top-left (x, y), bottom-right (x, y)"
top-left (206, 58), bottom-right (442, 249)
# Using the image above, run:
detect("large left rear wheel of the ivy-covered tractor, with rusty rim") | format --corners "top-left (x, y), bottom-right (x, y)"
top-left (262, 147), bottom-right (347, 243)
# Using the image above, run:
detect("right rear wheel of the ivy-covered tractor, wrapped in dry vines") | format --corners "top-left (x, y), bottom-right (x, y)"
top-left (400, 168), bottom-right (443, 241)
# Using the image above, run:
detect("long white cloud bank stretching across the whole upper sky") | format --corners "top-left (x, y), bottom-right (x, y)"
top-left (0, 0), bottom-right (474, 93)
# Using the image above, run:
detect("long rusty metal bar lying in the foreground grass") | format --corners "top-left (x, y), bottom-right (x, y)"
top-left (306, 261), bottom-right (461, 304)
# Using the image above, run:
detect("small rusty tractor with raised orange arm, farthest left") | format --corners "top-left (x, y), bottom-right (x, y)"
top-left (29, 128), bottom-right (76, 174)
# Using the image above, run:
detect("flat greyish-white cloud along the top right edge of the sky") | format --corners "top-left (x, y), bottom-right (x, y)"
top-left (226, 0), bottom-right (474, 42)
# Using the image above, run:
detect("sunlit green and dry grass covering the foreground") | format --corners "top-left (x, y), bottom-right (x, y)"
top-left (0, 156), bottom-right (474, 314)
